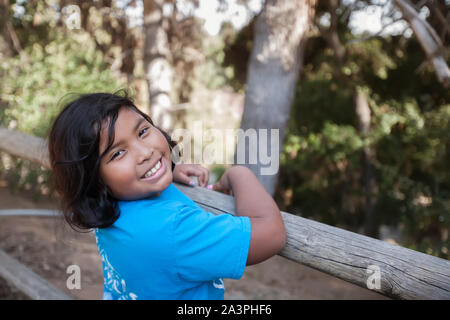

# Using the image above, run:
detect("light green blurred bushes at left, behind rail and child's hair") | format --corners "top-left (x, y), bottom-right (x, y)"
top-left (0, 32), bottom-right (125, 198)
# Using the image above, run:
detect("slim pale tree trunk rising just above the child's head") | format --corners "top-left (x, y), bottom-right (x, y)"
top-left (144, 0), bottom-right (173, 134)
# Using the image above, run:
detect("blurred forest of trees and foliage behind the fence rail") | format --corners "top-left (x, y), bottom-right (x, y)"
top-left (0, 0), bottom-right (450, 259)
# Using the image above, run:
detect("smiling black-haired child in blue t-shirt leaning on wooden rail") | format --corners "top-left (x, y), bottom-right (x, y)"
top-left (48, 93), bottom-right (286, 299)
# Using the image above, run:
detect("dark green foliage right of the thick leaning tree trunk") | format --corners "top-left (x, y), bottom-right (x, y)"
top-left (277, 35), bottom-right (450, 258)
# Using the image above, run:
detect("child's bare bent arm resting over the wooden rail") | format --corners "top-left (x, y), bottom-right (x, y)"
top-left (213, 166), bottom-right (286, 265)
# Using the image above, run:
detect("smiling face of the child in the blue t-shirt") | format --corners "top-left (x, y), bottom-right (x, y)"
top-left (99, 107), bottom-right (172, 200)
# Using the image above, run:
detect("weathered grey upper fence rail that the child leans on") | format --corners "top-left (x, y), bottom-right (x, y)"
top-left (0, 127), bottom-right (450, 299)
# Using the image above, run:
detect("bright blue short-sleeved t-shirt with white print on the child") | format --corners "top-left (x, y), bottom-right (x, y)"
top-left (95, 184), bottom-right (250, 300)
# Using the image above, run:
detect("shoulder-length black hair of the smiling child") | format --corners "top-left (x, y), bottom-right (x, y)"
top-left (48, 90), bottom-right (176, 230)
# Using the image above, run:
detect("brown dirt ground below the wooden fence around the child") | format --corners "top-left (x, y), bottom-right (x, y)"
top-left (0, 188), bottom-right (386, 300)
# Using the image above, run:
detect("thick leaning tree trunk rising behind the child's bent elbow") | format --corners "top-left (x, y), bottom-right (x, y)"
top-left (235, 0), bottom-right (316, 195)
